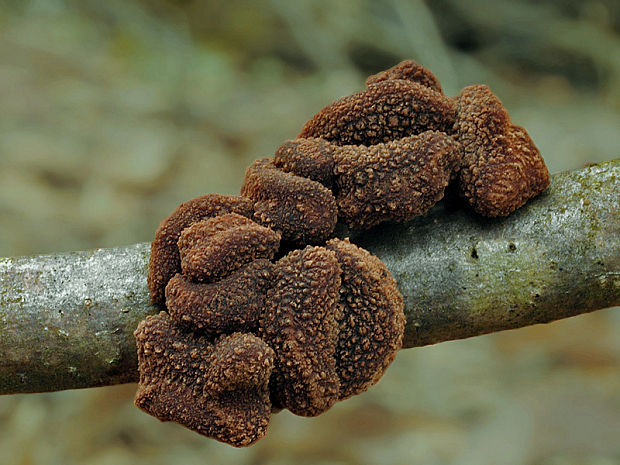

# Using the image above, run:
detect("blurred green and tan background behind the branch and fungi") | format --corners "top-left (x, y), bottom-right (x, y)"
top-left (0, 0), bottom-right (620, 465)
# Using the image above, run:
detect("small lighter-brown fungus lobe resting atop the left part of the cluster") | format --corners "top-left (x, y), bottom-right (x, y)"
top-left (178, 213), bottom-right (280, 282)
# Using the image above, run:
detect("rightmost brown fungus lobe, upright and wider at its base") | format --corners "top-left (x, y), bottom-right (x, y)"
top-left (454, 85), bottom-right (549, 216)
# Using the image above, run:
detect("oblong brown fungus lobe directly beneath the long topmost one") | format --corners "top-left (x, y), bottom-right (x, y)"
top-left (334, 131), bottom-right (461, 229)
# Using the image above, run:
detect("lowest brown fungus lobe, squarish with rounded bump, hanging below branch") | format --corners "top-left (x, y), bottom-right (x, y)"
top-left (135, 312), bottom-right (274, 447)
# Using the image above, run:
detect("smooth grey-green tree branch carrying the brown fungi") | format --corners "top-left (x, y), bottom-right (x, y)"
top-left (0, 159), bottom-right (620, 394)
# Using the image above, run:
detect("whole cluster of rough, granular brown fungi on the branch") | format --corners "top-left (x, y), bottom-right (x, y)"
top-left (135, 61), bottom-right (549, 446)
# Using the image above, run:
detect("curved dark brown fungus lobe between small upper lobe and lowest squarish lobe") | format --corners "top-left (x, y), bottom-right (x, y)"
top-left (166, 259), bottom-right (276, 334)
